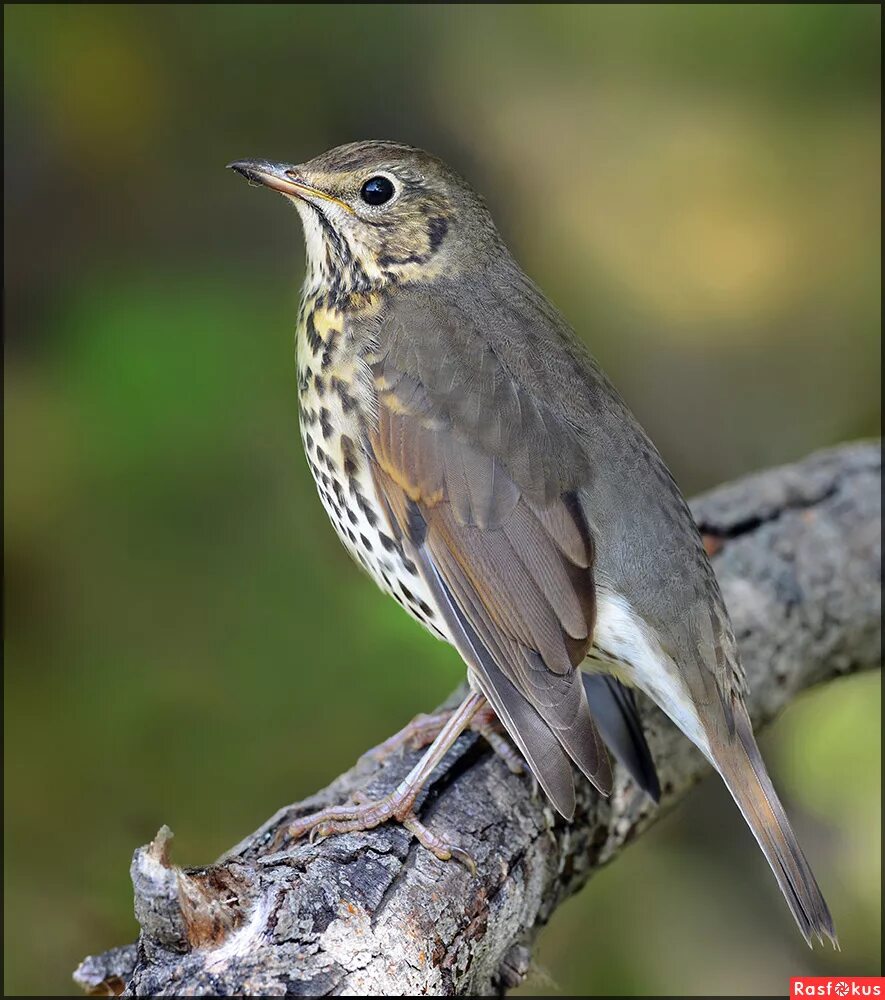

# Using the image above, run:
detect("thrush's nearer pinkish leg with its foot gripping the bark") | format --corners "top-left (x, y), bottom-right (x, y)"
top-left (288, 693), bottom-right (486, 870)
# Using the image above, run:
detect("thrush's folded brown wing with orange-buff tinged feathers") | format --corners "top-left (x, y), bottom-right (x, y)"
top-left (366, 300), bottom-right (611, 816)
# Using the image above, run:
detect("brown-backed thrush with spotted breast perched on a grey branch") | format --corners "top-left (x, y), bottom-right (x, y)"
top-left (229, 140), bottom-right (837, 946)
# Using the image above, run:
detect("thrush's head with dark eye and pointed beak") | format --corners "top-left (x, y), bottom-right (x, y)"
top-left (230, 141), bottom-right (499, 291)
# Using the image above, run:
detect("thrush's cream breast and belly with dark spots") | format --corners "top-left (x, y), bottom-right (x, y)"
top-left (296, 291), bottom-right (449, 640)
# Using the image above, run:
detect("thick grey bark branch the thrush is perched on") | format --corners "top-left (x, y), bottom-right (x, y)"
top-left (75, 443), bottom-right (881, 996)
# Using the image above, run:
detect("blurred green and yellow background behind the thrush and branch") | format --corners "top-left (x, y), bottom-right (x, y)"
top-left (4, 4), bottom-right (881, 996)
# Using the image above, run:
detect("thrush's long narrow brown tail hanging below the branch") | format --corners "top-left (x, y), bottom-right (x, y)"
top-left (712, 706), bottom-right (839, 948)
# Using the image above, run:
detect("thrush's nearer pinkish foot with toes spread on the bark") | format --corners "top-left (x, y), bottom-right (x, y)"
top-left (286, 787), bottom-right (476, 874)
